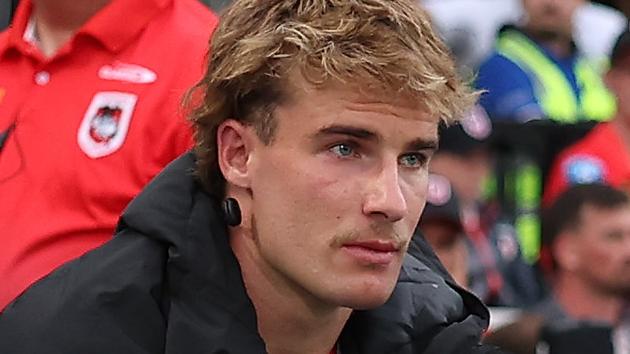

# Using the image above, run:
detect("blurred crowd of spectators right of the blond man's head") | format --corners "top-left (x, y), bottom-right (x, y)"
top-left (418, 0), bottom-right (630, 353)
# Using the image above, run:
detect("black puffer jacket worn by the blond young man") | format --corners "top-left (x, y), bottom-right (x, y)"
top-left (0, 154), bottom-right (506, 354)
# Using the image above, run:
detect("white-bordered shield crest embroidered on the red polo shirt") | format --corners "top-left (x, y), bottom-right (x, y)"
top-left (77, 92), bottom-right (138, 159)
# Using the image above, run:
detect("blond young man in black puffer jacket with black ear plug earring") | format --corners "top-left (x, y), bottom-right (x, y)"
top-left (0, 0), bottom-right (504, 354)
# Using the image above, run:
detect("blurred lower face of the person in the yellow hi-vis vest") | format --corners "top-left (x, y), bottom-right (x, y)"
top-left (523, 0), bottom-right (584, 38)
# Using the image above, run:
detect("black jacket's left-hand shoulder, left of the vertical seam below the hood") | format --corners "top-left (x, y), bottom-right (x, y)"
top-left (0, 231), bottom-right (167, 354)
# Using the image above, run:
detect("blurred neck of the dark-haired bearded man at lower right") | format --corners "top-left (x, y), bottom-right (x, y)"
top-left (554, 275), bottom-right (623, 325)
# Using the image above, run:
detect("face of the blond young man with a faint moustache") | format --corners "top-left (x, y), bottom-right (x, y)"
top-left (244, 81), bottom-right (438, 309)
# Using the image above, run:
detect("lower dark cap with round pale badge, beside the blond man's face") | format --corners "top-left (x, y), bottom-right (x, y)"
top-left (420, 173), bottom-right (462, 229)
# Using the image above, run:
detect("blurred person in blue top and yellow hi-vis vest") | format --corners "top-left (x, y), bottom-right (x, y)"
top-left (476, 0), bottom-right (615, 123)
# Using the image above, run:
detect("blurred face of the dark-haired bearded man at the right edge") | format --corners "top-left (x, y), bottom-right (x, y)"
top-left (572, 205), bottom-right (630, 294)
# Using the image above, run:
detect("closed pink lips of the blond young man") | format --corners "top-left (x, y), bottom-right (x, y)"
top-left (341, 240), bottom-right (401, 266)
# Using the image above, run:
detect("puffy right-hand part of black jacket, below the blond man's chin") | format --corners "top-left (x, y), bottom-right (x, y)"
top-left (341, 249), bottom-right (490, 354)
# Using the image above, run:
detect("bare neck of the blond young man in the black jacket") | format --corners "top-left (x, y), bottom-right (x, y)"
top-left (230, 227), bottom-right (352, 354)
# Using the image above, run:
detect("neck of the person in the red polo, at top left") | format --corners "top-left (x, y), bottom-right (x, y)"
top-left (33, 0), bottom-right (111, 57)
